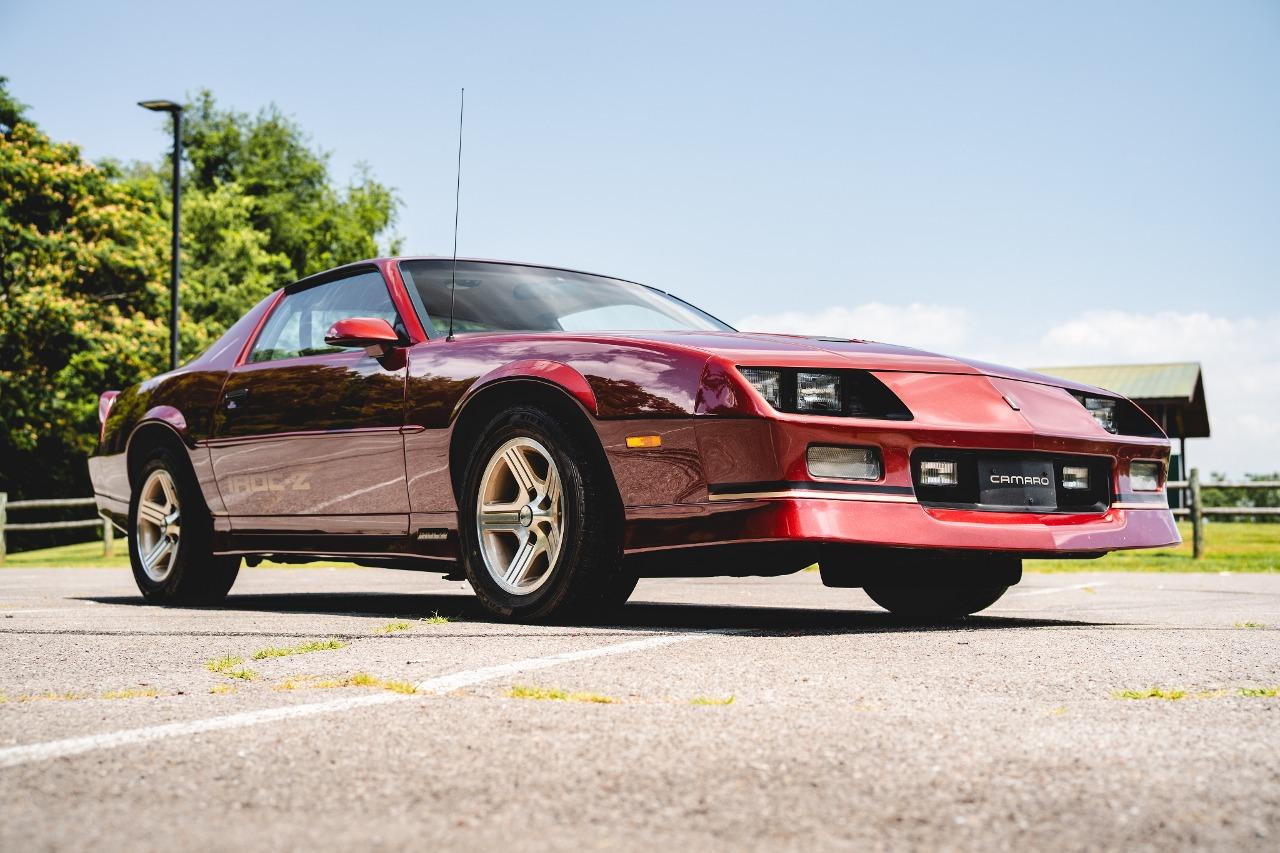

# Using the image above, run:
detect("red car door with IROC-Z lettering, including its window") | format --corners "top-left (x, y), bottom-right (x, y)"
top-left (209, 268), bottom-right (408, 537)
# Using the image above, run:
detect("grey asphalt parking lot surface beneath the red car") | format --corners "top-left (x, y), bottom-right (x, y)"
top-left (0, 560), bottom-right (1280, 852)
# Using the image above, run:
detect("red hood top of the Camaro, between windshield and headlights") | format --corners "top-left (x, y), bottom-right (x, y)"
top-left (596, 332), bottom-right (1110, 393)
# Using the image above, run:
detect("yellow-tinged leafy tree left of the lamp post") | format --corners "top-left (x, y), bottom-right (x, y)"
top-left (0, 79), bottom-right (165, 494)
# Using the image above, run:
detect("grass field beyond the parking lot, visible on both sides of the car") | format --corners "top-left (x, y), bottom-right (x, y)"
top-left (5, 521), bottom-right (1280, 573)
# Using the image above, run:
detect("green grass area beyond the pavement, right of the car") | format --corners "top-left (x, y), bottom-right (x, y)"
top-left (1023, 521), bottom-right (1280, 574)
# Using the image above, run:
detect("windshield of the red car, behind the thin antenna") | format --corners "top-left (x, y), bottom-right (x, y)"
top-left (401, 259), bottom-right (732, 337)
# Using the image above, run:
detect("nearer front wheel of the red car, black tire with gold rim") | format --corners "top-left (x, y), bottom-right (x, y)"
top-left (460, 406), bottom-right (636, 621)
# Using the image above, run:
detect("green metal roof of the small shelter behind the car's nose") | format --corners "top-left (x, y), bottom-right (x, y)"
top-left (1032, 361), bottom-right (1210, 438)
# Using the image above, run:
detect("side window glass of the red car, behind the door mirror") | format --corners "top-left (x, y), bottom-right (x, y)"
top-left (248, 266), bottom-right (399, 361)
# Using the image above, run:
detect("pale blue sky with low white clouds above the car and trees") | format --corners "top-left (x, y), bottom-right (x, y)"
top-left (0, 0), bottom-right (1280, 471)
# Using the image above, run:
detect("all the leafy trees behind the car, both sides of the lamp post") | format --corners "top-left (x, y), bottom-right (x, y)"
top-left (0, 77), bottom-right (398, 527)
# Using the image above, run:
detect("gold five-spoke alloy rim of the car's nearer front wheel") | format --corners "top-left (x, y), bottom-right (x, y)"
top-left (476, 437), bottom-right (564, 596)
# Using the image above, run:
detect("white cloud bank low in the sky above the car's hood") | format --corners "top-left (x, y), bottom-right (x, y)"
top-left (739, 302), bottom-right (1280, 475)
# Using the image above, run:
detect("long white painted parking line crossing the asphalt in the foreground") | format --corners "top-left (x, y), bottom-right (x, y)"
top-left (0, 631), bottom-right (722, 767)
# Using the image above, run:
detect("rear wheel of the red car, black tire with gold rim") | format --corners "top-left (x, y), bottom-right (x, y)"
top-left (129, 447), bottom-right (241, 605)
